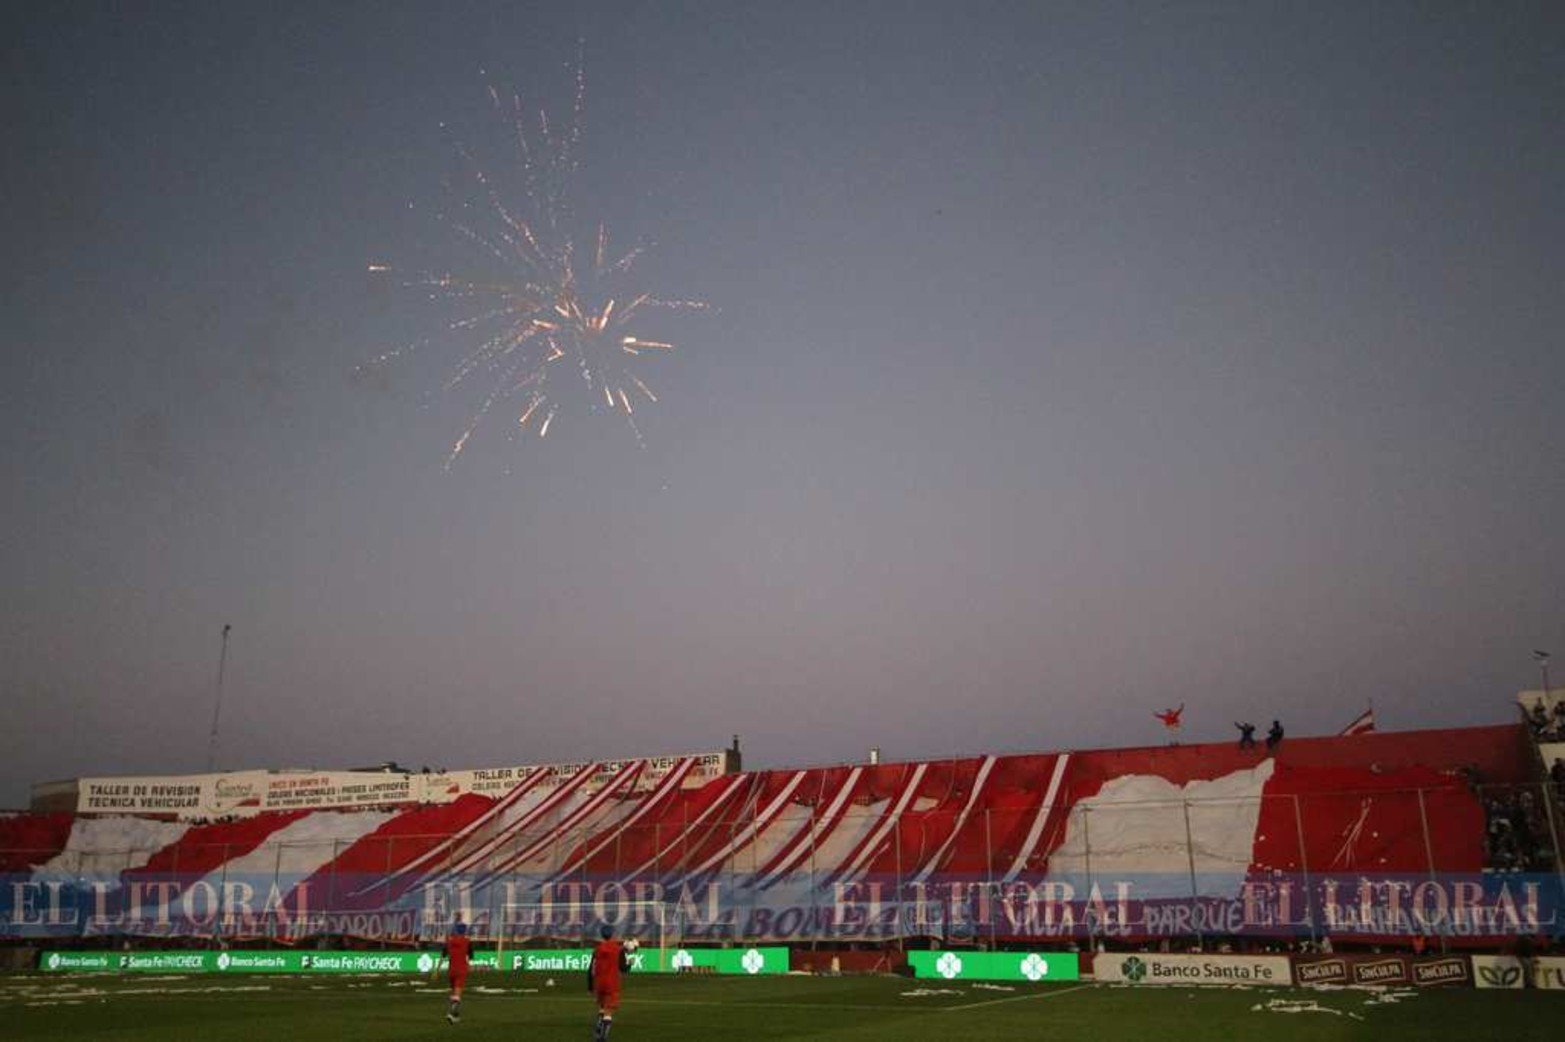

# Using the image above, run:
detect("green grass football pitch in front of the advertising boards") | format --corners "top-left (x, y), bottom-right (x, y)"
top-left (0, 973), bottom-right (1565, 1042)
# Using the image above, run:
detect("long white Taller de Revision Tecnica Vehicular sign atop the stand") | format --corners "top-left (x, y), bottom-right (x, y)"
top-left (77, 753), bottom-right (728, 818)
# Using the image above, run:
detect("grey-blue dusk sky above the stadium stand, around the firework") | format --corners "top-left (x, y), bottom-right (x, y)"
top-left (0, 2), bottom-right (1565, 806)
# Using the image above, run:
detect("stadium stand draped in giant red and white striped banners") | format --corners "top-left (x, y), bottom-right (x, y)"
top-left (0, 724), bottom-right (1556, 936)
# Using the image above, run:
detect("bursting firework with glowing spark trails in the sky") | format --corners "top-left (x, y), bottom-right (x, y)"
top-left (360, 61), bottom-right (707, 469)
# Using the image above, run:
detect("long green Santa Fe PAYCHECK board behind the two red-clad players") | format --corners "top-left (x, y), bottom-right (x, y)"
top-left (39, 948), bottom-right (789, 975)
